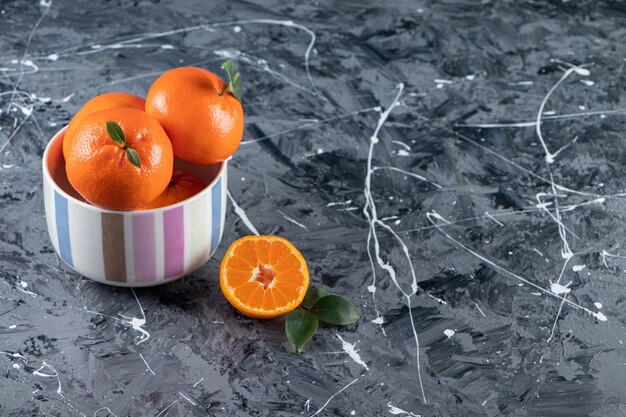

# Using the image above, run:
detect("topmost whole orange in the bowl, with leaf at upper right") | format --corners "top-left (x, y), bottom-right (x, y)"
top-left (146, 67), bottom-right (243, 165)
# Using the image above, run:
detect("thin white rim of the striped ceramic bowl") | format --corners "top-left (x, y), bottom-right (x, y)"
top-left (41, 126), bottom-right (228, 214)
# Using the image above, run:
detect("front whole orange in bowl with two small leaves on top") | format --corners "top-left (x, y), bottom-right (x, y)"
top-left (65, 108), bottom-right (174, 210)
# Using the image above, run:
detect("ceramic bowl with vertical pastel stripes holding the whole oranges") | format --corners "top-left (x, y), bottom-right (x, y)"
top-left (43, 129), bottom-right (227, 287)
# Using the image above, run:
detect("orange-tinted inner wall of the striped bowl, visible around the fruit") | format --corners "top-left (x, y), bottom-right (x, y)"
top-left (45, 129), bottom-right (223, 203)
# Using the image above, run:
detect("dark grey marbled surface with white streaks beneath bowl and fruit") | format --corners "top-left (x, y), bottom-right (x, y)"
top-left (0, 0), bottom-right (626, 417)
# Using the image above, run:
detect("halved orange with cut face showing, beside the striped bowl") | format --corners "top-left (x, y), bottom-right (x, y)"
top-left (220, 236), bottom-right (309, 319)
